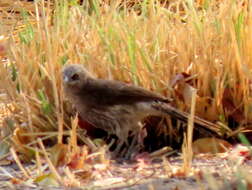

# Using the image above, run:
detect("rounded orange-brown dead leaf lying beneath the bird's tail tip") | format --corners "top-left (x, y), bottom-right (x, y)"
top-left (192, 138), bottom-right (232, 154)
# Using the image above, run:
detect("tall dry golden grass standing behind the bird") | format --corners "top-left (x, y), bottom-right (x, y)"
top-left (0, 0), bottom-right (252, 189)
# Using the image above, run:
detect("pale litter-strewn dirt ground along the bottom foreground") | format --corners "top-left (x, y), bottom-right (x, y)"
top-left (0, 156), bottom-right (249, 190)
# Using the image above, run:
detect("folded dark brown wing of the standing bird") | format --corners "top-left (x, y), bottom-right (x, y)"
top-left (82, 79), bottom-right (171, 105)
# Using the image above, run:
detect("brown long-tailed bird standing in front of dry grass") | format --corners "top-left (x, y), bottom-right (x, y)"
top-left (62, 64), bottom-right (220, 157)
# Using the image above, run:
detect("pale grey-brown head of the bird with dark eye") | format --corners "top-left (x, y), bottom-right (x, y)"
top-left (62, 64), bottom-right (92, 87)
